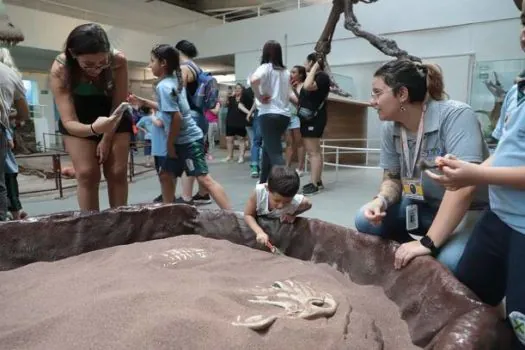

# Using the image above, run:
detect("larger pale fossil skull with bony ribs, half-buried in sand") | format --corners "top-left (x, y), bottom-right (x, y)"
top-left (232, 280), bottom-right (337, 331)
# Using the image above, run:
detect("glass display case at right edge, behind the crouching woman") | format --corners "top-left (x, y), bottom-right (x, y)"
top-left (470, 60), bottom-right (525, 141)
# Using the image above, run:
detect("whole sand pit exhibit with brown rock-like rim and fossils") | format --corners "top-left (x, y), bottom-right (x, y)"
top-left (0, 205), bottom-right (509, 350)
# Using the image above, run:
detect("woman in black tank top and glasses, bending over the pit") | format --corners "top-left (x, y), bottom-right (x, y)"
top-left (50, 23), bottom-right (132, 211)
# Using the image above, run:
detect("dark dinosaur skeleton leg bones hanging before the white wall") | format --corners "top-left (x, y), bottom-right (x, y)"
top-left (315, 0), bottom-right (420, 97)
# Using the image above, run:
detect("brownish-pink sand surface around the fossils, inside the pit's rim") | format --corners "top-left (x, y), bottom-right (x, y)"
top-left (0, 236), bottom-right (417, 350)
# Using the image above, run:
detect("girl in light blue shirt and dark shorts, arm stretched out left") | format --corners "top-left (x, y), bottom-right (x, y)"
top-left (130, 44), bottom-right (231, 209)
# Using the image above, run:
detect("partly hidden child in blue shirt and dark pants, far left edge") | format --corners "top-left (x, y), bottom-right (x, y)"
top-left (4, 129), bottom-right (27, 220)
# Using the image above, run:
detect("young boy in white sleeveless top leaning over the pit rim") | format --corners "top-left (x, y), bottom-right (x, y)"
top-left (244, 166), bottom-right (312, 245)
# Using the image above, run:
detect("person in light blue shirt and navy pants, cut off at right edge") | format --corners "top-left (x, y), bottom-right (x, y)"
top-left (427, 80), bottom-right (525, 349)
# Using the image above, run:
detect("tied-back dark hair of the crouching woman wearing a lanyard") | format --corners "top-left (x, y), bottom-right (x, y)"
top-left (374, 59), bottom-right (447, 102)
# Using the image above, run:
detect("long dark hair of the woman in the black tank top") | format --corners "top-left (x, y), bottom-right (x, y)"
top-left (64, 23), bottom-right (113, 93)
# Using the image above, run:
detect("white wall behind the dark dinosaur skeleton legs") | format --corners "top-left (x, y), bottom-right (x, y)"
top-left (189, 0), bottom-right (524, 142)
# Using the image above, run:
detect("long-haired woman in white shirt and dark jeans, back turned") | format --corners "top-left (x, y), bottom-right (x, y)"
top-left (250, 40), bottom-right (292, 183)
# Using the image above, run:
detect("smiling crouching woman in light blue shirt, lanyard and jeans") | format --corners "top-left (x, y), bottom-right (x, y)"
top-left (355, 59), bottom-right (489, 271)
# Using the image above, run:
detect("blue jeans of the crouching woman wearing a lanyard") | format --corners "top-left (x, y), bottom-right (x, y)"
top-left (355, 197), bottom-right (472, 273)
